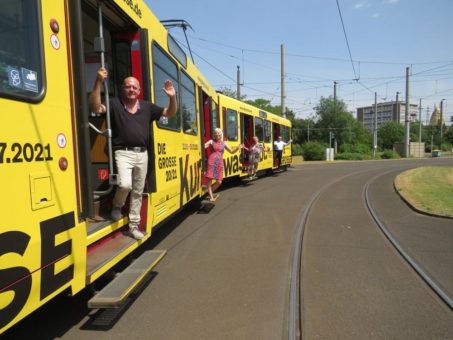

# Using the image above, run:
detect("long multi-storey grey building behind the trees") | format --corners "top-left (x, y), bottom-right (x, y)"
top-left (357, 101), bottom-right (419, 132)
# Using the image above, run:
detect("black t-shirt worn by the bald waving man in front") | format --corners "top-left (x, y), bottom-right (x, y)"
top-left (110, 98), bottom-right (164, 147)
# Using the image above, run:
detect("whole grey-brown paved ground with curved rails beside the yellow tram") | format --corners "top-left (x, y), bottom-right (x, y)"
top-left (2, 159), bottom-right (453, 340)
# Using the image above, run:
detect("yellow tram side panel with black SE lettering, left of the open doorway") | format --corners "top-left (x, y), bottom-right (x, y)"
top-left (0, 1), bottom-right (86, 333)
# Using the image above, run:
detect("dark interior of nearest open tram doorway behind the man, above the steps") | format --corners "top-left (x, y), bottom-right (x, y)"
top-left (72, 1), bottom-right (155, 223)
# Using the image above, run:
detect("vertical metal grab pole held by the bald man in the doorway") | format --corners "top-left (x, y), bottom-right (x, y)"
top-left (98, 0), bottom-right (118, 185)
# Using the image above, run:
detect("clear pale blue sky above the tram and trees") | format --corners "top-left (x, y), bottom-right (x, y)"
top-left (145, 0), bottom-right (453, 120)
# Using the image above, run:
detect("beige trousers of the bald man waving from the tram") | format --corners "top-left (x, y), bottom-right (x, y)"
top-left (113, 150), bottom-right (148, 228)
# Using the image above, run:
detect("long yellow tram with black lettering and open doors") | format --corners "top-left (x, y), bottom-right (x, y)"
top-left (0, 0), bottom-right (291, 334)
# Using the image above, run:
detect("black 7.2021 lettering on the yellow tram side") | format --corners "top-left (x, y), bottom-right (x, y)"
top-left (0, 142), bottom-right (53, 164)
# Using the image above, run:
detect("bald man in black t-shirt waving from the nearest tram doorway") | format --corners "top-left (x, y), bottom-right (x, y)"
top-left (89, 67), bottom-right (177, 240)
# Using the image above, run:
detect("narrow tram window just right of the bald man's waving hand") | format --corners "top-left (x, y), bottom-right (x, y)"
top-left (180, 73), bottom-right (197, 135)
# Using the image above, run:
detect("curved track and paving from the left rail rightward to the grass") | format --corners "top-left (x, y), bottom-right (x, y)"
top-left (296, 161), bottom-right (453, 339)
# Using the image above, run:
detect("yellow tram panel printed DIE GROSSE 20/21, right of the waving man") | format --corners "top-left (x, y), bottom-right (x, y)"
top-left (130, 1), bottom-right (215, 228)
